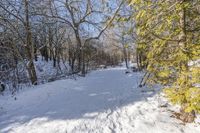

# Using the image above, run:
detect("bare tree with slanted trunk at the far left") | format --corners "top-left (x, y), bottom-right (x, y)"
top-left (0, 0), bottom-right (37, 84)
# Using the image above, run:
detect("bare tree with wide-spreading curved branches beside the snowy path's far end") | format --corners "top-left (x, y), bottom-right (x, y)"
top-left (36, 0), bottom-right (124, 76)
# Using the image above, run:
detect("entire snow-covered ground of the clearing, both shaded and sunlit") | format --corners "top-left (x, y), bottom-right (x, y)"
top-left (0, 68), bottom-right (200, 133)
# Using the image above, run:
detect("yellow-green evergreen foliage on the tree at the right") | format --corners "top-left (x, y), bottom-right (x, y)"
top-left (129, 0), bottom-right (200, 112)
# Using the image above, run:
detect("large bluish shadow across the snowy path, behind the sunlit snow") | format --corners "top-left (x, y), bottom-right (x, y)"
top-left (0, 69), bottom-right (159, 132)
